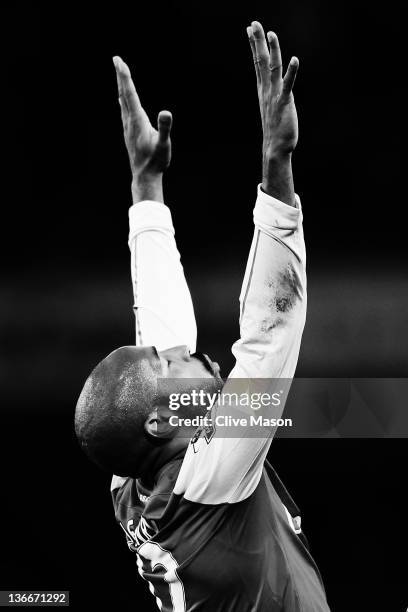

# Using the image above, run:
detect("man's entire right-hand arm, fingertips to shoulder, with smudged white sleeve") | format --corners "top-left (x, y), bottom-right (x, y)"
top-left (175, 22), bottom-right (306, 504)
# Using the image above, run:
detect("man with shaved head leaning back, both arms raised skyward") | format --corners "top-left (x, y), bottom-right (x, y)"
top-left (76, 22), bottom-right (329, 612)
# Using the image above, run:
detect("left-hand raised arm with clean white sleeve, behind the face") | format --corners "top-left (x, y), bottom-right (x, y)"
top-left (113, 57), bottom-right (197, 352)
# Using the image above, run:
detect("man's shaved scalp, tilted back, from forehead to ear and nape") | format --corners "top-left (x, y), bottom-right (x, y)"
top-left (75, 346), bottom-right (161, 477)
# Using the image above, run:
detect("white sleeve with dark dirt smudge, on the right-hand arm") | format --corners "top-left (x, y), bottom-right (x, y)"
top-left (175, 188), bottom-right (306, 504)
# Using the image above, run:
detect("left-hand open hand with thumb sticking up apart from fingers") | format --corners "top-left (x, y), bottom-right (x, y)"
top-left (113, 57), bottom-right (172, 181)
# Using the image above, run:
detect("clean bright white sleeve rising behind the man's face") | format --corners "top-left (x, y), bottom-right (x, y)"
top-left (129, 201), bottom-right (197, 352)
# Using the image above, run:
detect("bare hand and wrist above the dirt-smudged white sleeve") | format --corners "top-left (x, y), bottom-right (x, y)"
top-left (247, 21), bottom-right (299, 205)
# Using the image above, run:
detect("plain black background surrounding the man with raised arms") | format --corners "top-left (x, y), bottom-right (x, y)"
top-left (0, 0), bottom-right (408, 612)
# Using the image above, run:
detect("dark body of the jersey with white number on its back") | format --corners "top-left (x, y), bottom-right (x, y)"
top-left (112, 448), bottom-right (329, 612)
